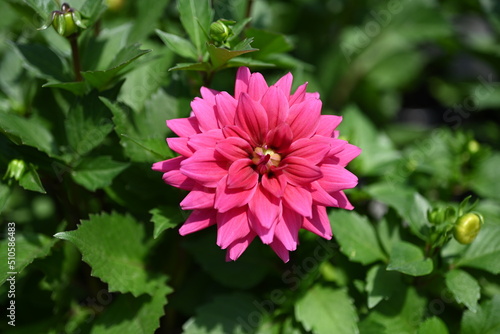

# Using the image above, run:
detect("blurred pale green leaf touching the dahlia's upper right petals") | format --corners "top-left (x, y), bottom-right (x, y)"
top-left (338, 105), bottom-right (400, 175)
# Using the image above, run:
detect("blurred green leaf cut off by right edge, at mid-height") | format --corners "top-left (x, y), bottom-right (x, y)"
top-left (470, 153), bottom-right (500, 200)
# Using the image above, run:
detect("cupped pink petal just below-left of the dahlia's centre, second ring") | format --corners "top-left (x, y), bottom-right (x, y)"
top-left (214, 176), bottom-right (257, 212)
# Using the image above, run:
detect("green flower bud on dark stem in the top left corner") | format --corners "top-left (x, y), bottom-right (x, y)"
top-left (38, 3), bottom-right (87, 37)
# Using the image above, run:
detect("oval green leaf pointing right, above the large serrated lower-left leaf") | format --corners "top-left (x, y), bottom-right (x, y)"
top-left (71, 156), bottom-right (129, 191)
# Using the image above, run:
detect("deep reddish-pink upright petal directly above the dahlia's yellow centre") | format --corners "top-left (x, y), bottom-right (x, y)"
top-left (235, 93), bottom-right (267, 145)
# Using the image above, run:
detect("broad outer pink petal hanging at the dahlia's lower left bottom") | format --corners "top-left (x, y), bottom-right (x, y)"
top-left (217, 206), bottom-right (252, 249)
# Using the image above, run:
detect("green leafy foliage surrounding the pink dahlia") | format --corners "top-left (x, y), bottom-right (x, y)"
top-left (0, 0), bottom-right (500, 334)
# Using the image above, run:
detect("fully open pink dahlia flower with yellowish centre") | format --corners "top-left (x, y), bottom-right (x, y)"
top-left (153, 67), bottom-right (360, 262)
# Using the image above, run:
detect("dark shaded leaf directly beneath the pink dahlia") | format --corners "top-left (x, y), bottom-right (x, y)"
top-left (185, 233), bottom-right (274, 289)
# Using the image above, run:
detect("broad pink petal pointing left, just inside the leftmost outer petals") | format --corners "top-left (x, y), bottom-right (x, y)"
top-left (180, 149), bottom-right (227, 188)
